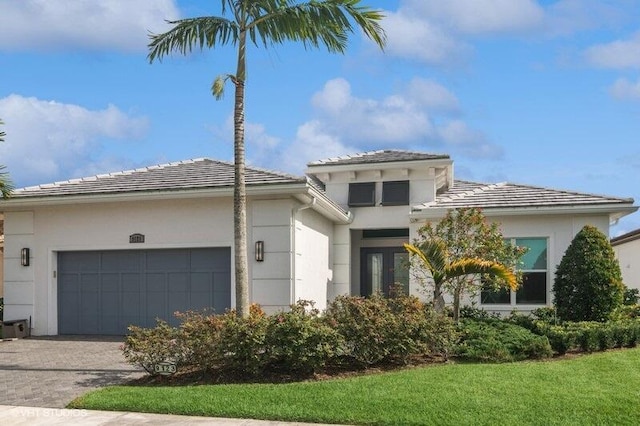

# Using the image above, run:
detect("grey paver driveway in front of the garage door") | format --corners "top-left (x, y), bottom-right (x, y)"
top-left (0, 336), bottom-right (142, 408)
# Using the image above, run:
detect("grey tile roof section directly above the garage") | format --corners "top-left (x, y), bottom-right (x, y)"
top-left (12, 158), bottom-right (307, 198)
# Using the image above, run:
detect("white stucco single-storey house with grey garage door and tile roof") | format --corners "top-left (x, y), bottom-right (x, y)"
top-left (0, 150), bottom-right (637, 335)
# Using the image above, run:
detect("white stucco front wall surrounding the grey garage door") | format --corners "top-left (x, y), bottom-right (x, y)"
top-left (5, 197), bottom-right (310, 335)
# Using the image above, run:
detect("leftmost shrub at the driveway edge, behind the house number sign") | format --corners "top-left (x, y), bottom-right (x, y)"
top-left (122, 320), bottom-right (190, 375)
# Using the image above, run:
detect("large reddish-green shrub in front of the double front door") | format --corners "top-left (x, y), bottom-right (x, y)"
top-left (325, 294), bottom-right (455, 367)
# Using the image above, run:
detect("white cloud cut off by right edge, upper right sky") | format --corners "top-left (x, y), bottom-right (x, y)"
top-left (585, 32), bottom-right (640, 69)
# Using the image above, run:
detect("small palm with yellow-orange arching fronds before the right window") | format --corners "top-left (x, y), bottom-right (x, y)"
top-left (404, 238), bottom-right (518, 321)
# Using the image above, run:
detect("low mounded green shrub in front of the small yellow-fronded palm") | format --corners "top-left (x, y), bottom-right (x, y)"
top-left (454, 319), bottom-right (553, 362)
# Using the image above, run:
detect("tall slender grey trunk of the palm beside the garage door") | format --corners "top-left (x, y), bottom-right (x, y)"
top-left (233, 31), bottom-right (249, 318)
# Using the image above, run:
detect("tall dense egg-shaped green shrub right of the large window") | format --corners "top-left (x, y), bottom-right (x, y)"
top-left (553, 225), bottom-right (624, 321)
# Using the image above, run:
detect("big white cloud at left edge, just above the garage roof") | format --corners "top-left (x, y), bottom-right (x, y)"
top-left (0, 95), bottom-right (148, 186)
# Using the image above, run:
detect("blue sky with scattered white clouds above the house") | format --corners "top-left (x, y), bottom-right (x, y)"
top-left (0, 0), bottom-right (640, 234)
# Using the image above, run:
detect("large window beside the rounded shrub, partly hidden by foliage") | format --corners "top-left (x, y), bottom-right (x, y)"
top-left (480, 238), bottom-right (548, 305)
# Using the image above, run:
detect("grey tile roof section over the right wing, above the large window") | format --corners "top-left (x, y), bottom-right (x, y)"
top-left (415, 180), bottom-right (633, 210)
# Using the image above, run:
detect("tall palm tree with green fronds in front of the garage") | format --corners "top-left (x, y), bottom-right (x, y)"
top-left (148, 0), bottom-right (385, 317)
